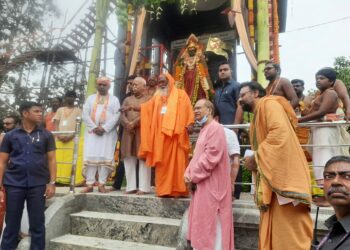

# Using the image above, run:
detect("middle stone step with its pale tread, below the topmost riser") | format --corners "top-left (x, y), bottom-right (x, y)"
top-left (71, 211), bottom-right (181, 247)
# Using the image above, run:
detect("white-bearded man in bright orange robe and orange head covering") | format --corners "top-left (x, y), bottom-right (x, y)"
top-left (139, 74), bottom-right (193, 197)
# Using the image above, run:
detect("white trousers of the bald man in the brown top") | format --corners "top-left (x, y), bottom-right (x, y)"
top-left (124, 156), bottom-right (151, 193)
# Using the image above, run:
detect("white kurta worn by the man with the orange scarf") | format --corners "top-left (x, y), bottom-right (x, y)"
top-left (83, 94), bottom-right (120, 165)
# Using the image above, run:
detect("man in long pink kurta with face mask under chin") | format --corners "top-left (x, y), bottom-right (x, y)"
top-left (184, 99), bottom-right (234, 250)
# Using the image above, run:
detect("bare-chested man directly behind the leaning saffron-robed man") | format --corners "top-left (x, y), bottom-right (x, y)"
top-left (264, 62), bottom-right (299, 108)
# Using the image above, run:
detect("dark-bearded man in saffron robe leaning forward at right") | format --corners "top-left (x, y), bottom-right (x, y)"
top-left (239, 82), bottom-right (313, 250)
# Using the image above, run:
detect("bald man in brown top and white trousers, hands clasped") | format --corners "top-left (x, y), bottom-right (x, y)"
top-left (121, 77), bottom-right (151, 194)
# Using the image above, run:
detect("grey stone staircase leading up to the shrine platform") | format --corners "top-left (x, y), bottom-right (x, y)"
top-left (48, 193), bottom-right (189, 250)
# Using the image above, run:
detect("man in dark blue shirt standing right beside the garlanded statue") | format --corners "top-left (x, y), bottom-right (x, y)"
top-left (214, 62), bottom-right (240, 125)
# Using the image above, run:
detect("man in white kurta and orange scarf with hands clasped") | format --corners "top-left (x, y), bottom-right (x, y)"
top-left (82, 77), bottom-right (120, 193)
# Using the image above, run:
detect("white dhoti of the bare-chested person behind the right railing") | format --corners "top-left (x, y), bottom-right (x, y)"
top-left (311, 126), bottom-right (349, 180)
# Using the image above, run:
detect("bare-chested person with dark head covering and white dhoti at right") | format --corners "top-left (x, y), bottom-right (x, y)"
top-left (298, 68), bottom-right (349, 205)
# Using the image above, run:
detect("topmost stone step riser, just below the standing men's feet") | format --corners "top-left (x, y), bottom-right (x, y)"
top-left (85, 192), bottom-right (190, 219)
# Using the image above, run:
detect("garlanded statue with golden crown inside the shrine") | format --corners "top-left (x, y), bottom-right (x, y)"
top-left (174, 34), bottom-right (213, 106)
